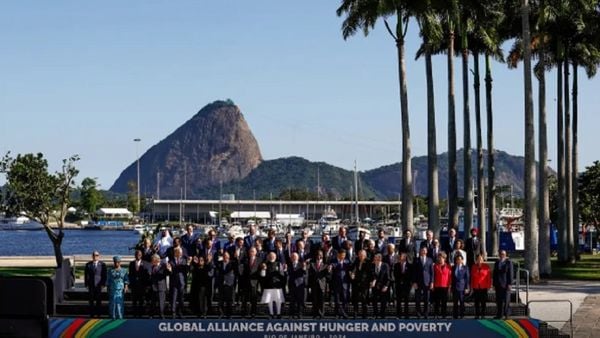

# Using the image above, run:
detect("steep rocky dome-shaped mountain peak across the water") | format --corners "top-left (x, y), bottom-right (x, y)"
top-left (110, 100), bottom-right (262, 198)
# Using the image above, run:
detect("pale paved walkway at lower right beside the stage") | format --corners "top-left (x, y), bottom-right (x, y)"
top-left (521, 280), bottom-right (600, 338)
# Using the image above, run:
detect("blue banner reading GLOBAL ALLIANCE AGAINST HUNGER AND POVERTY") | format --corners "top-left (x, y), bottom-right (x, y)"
top-left (50, 318), bottom-right (539, 338)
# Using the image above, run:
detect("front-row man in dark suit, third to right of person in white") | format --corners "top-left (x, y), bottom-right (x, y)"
top-left (329, 249), bottom-right (351, 319)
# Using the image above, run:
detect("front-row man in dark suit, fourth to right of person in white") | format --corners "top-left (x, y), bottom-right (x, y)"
top-left (350, 250), bottom-right (373, 319)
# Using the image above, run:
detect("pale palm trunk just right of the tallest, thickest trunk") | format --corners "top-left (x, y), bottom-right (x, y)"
top-left (537, 67), bottom-right (552, 276)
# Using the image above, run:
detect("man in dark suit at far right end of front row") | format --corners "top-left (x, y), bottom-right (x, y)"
top-left (492, 250), bottom-right (513, 319)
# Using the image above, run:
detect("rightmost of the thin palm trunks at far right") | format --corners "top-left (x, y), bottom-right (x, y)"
top-left (571, 63), bottom-right (579, 258)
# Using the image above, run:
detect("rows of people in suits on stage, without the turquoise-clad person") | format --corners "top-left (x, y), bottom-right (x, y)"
top-left (85, 225), bottom-right (512, 318)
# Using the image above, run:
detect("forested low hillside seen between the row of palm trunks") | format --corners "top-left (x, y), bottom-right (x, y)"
top-left (363, 149), bottom-right (524, 199)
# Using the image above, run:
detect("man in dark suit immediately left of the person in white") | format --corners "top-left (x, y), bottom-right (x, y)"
top-left (239, 248), bottom-right (263, 318)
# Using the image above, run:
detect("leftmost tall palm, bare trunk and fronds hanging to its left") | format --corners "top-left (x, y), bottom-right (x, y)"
top-left (336, 0), bottom-right (414, 232)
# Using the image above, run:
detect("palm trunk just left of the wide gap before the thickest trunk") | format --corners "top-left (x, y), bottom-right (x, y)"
top-left (485, 53), bottom-right (500, 255)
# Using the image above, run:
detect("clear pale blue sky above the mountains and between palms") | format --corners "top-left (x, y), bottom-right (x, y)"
top-left (0, 0), bottom-right (600, 189)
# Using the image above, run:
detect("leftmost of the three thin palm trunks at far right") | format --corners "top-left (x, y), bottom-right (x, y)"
top-left (556, 61), bottom-right (569, 262)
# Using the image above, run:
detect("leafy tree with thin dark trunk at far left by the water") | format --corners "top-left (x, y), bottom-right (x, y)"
top-left (0, 153), bottom-right (79, 268)
